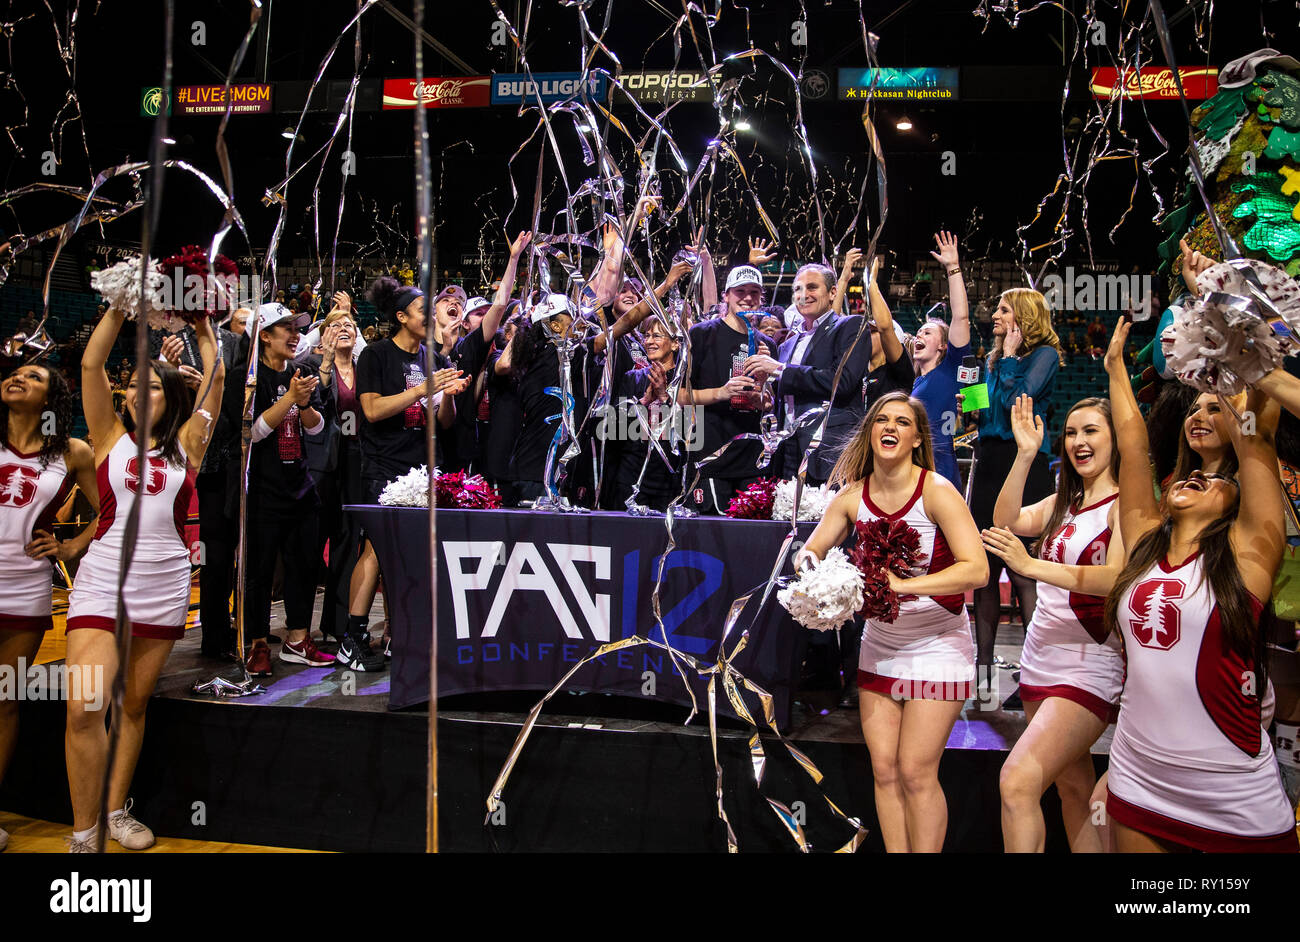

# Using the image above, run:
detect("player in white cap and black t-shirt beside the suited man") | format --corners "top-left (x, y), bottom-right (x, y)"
top-left (677, 265), bottom-right (776, 513)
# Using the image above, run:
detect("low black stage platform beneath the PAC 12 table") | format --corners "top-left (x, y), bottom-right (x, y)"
top-left (0, 600), bottom-right (1110, 852)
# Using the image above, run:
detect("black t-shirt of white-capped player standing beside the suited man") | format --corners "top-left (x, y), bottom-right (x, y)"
top-left (690, 317), bottom-right (776, 479)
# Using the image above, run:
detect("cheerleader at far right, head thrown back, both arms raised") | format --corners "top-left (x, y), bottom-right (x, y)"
top-left (1106, 321), bottom-right (1300, 852)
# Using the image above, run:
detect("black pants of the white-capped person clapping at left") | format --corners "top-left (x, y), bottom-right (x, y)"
top-left (244, 500), bottom-right (319, 642)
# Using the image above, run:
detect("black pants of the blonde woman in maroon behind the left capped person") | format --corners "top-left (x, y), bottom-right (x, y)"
top-left (312, 438), bottom-right (367, 638)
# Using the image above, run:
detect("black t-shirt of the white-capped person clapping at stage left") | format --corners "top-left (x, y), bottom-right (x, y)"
top-left (248, 361), bottom-right (324, 518)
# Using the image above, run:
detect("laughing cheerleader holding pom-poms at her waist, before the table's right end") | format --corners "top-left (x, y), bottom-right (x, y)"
top-left (796, 392), bottom-right (988, 852)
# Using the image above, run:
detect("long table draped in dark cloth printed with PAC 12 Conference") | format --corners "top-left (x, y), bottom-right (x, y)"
top-left (346, 505), bottom-right (814, 729)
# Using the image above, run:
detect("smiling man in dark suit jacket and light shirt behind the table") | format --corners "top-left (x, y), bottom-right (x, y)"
top-left (745, 265), bottom-right (871, 485)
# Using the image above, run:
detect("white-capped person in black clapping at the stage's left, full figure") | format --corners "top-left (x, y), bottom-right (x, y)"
top-left (243, 303), bottom-right (334, 677)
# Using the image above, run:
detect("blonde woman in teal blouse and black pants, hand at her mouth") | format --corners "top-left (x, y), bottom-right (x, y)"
top-left (970, 288), bottom-right (1065, 682)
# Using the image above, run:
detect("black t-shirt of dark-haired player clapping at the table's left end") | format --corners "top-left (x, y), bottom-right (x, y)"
top-left (356, 338), bottom-right (449, 481)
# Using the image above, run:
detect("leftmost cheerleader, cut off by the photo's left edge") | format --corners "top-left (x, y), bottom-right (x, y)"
top-left (0, 364), bottom-right (99, 851)
